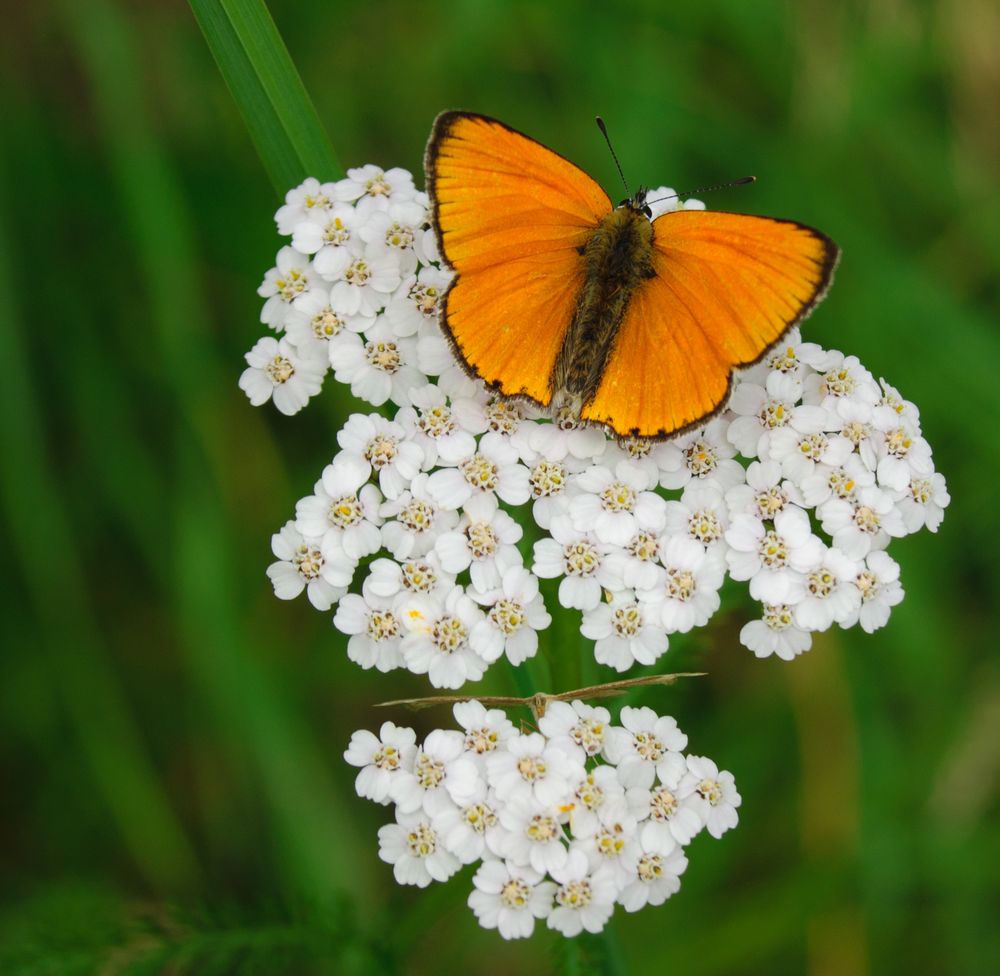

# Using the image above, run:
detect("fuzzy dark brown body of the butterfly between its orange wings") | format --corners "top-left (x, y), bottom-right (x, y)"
top-left (552, 205), bottom-right (655, 406)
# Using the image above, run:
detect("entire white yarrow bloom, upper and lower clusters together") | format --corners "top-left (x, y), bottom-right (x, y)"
top-left (246, 165), bottom-right (950, 939)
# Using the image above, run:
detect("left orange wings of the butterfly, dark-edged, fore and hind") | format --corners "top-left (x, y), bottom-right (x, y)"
top-left (425, 112), bottom-right (611, 405)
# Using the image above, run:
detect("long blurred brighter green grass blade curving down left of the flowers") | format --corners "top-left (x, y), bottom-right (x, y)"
top-left (63, 0), bottom-right (366, 904)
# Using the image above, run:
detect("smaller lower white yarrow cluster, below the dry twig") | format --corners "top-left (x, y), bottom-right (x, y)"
top-left (344, 701), bottom-right (740, 939)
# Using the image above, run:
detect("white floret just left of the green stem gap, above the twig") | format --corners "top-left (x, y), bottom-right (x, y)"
top-left (472, 564), bottom-right (552, 666)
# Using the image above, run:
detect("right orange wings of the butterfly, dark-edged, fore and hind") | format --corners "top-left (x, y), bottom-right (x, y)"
top-left (581, 210), bottom-right (839, 439)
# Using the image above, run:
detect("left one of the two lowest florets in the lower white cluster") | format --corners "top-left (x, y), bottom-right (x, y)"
top-left (469, 860), bottom-right (556, 939)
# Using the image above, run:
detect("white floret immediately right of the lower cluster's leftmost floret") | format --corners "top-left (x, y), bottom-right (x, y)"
top-left (391, 729), bottom-right (483, 817)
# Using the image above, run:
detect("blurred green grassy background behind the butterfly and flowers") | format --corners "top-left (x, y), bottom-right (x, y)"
top-left (0, 0), bottom-right (1000, 976)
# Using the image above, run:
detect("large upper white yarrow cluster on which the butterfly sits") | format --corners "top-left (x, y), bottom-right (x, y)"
top-left (241, 166), bottom-right (949, 688)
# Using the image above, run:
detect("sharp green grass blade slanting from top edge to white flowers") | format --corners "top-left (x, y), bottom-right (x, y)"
top-left (189, 0), bottom-right (343, 194)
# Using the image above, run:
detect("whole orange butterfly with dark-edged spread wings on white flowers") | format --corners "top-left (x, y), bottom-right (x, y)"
top-left (424, 112), bottom-right (839, 440)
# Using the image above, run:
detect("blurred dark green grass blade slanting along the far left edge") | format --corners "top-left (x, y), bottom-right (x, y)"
top-left (0, 143), bottom-right (200, 892)
